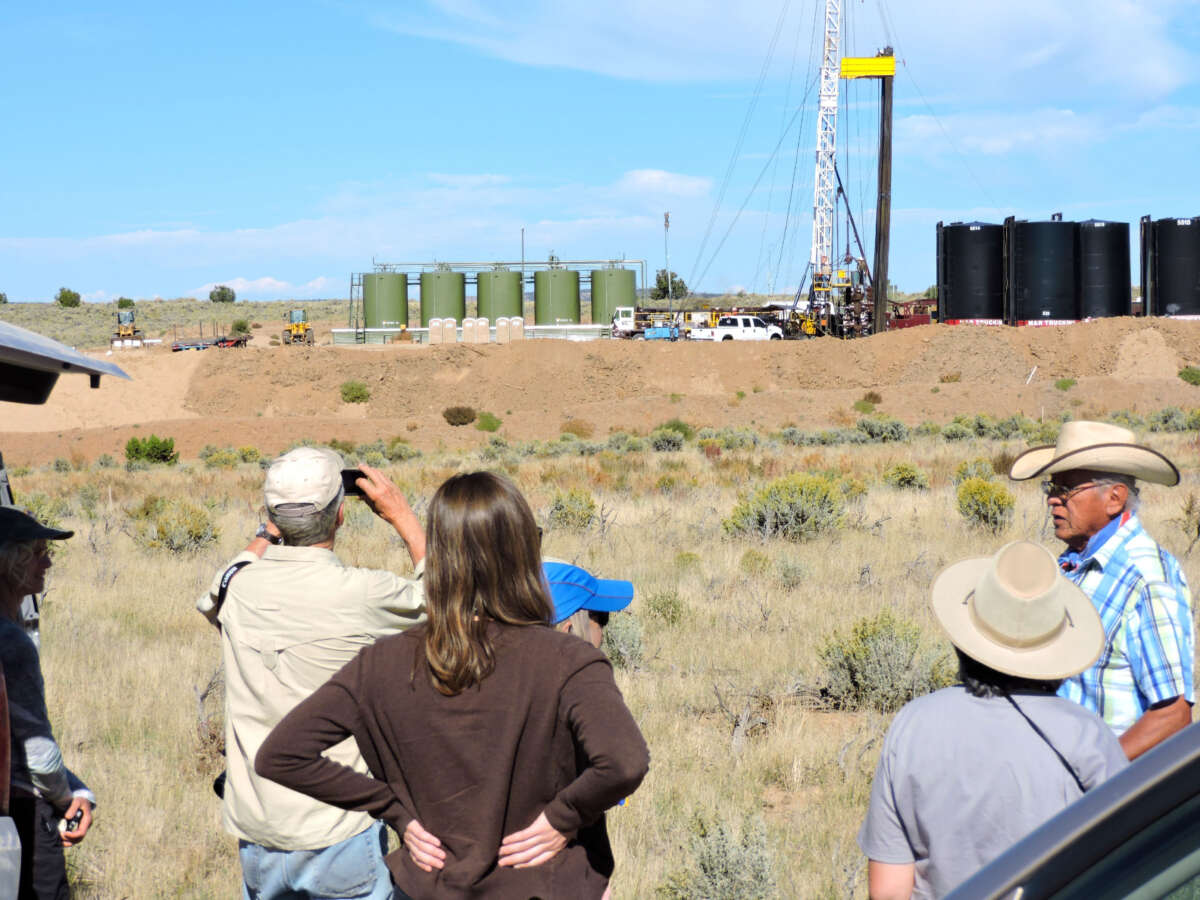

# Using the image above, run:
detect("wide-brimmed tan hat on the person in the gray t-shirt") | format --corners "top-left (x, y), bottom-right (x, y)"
top-left (932, 541), bottom-right (1104, 680)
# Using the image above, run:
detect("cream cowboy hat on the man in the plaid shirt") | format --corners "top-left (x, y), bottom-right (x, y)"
top-left (1008, 421), bottom-right (1180, 487)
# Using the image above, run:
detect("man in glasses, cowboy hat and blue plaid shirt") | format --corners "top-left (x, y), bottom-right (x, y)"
top-left (1009, 421), bottom-right (1194, 760)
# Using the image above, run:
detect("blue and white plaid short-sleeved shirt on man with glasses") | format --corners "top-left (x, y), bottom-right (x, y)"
top-left (1058, 515), bottom-right (1195, 734)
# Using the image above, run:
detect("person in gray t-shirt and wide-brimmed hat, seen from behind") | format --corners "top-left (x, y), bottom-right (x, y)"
top-left (858, 541), bottom-right (1127, 900)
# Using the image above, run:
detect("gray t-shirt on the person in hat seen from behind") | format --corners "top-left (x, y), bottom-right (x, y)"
top-left (858, 685), bottom-right (1129, 898)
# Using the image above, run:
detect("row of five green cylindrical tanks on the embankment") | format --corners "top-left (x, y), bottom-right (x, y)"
top-left (362, 266), bottom-right (637, 329)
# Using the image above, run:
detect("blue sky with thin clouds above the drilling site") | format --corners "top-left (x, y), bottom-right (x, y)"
top-left (0, 0), bottom-right (1200, 301)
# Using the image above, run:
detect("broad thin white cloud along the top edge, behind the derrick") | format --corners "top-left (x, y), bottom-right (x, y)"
top-left (376, 0), bottom-right (1195, 103)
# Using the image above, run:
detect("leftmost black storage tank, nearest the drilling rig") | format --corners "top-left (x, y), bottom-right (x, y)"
top-left (937, 222), bottom-right (1004, 325)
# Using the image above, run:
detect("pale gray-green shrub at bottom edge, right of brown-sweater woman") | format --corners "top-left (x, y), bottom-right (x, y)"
top-left (654, 816), bottom-right (779, 900)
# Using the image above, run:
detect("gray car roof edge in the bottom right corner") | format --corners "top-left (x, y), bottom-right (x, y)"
top-left (946, 724), bottom-right (1200, 900)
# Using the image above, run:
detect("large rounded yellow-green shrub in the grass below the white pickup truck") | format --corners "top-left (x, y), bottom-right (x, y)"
top-left (724, 473), bottom-right (846, 541)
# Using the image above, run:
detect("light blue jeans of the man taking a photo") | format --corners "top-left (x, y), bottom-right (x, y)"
top-left (238, 822), bottom-right (392, 900)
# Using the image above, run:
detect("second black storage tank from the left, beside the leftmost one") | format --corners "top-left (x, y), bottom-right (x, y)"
top-left (1004, 218), bottom-right (1079, 325)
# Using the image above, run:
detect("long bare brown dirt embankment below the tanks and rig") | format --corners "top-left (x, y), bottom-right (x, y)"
top-left (7, 319), bottom-right (1200, 463)
